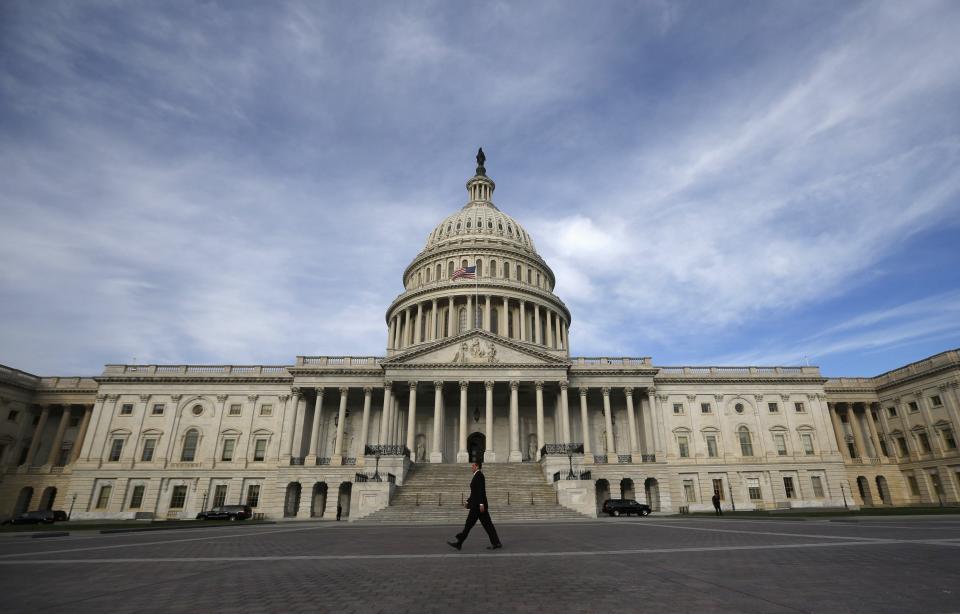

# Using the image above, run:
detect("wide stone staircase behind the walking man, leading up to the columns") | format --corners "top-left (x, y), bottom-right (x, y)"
top-left (358, 463), bottom-right (586, 524)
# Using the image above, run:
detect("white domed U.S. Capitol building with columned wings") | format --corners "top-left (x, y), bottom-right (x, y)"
top-left (0, 155), bottom-right (960, 520)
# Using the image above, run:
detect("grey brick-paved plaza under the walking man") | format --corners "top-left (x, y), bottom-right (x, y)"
top-left (0, 516), bottom-right (960, 613)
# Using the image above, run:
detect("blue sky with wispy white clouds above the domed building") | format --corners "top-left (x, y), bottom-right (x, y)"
top-left (0, 0), bottom-right (960, 375)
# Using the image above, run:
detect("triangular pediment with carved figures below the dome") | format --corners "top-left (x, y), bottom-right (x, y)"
top-left (381, 329), bottom-right (570, 367)
